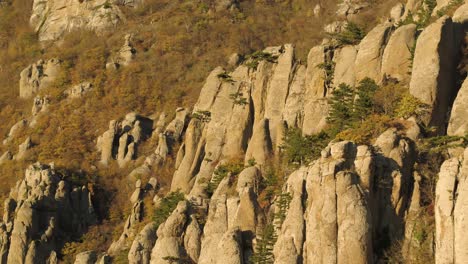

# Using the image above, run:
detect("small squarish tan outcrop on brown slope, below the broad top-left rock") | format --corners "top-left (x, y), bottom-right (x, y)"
top-left (19, 59), bottom-right (61, 98)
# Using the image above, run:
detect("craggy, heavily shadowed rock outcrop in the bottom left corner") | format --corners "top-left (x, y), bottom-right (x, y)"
top-left (0, 163), bottom-right (96, 263)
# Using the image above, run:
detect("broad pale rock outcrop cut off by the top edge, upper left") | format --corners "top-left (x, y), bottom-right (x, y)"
top-left (30, 0), bottom-right (125, 41)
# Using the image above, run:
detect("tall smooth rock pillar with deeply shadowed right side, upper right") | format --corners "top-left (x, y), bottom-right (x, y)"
top-left (410, 16), bottom-right (459, 132)
